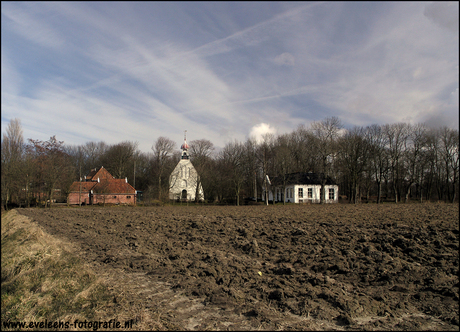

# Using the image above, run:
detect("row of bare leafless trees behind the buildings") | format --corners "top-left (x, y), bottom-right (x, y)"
top-left (1, 117), bottom-right (459, 208)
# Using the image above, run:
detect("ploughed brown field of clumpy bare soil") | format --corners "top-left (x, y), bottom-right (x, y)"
top-left (18, 204), bottom-right (459, 330)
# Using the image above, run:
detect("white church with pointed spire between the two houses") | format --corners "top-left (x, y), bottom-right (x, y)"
top-left (169, 135), bottom-right (204, 201)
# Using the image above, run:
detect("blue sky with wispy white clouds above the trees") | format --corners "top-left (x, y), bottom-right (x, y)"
top-left (1, 1), bottom-right (459, 152)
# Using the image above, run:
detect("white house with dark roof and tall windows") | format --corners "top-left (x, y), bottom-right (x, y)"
top-left (262, 173), bottom-right (339, 203)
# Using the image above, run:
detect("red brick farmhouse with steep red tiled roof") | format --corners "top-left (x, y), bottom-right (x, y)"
top-left (67, 167), bottom-right (136, 205)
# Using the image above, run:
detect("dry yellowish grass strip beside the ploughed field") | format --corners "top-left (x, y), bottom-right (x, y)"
top-left (1, 210), bottom-right (167, 331)
